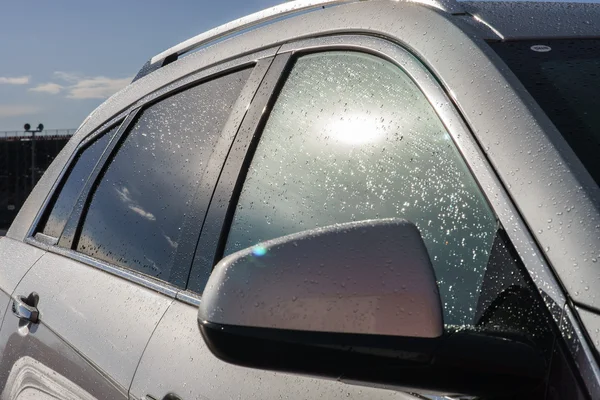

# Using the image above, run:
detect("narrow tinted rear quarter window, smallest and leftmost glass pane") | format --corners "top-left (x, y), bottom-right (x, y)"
top-left (42, 126), bottom-right (118, 238)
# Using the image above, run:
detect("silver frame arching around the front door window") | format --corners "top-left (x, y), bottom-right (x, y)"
top-left (195, 35), bottom-right (566, 310)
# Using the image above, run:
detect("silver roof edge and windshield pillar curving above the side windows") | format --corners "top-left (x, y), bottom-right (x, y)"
top-left (8, 1), bottom-right (600, 308)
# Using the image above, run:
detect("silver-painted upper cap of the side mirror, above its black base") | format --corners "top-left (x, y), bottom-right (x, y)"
top-left (204, 219), bottom-right (444, 338)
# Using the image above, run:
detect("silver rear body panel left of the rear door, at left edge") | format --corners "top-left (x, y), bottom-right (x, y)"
top-left (0, 237), bottom-right (45, 326)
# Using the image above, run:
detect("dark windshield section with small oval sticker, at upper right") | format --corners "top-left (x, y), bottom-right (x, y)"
top-left (492, 39), bottom-right (600, 184)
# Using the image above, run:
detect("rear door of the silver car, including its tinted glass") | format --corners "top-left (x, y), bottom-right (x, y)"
top-left (0, 58), bottom-right (268, 399)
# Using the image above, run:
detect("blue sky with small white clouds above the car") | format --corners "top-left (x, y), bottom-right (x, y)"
top-left (0, 0), bottom-right (282, 131)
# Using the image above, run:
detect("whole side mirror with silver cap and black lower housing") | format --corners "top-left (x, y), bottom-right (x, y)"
top-left (198, 219), bottom-right (546, 395)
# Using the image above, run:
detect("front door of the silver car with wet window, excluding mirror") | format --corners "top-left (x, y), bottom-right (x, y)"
top-left (131, 36), bottom-right (572, 399)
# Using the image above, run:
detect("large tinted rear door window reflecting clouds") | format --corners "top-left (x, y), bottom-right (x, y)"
top-left (77, 70), bottom-right (251, 285)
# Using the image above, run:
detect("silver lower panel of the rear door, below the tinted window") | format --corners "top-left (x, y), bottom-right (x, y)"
top-left (0, 253), bottom-right (172, 398)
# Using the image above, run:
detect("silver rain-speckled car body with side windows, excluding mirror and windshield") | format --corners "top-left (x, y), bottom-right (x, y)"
top-left (0, 0), bottom-right (600, 399)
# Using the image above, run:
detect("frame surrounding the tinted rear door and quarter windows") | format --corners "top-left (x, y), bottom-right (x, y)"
top-left (25, 48), bottom-right (277, 298)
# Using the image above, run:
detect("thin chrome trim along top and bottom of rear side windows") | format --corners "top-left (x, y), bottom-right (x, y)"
top-left (25, 47), bottom-right (278, 306)
